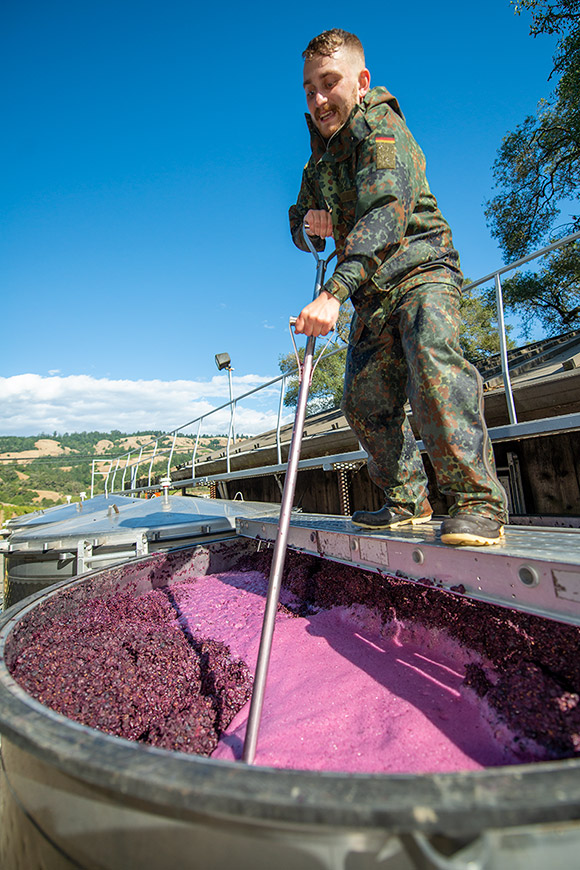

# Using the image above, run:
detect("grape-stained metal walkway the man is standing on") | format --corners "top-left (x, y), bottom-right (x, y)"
top-left (236, 513), bottom-right (580, 625)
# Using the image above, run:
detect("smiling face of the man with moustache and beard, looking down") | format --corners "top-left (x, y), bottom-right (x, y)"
top-left (304, 48), bottom-right (370, 139)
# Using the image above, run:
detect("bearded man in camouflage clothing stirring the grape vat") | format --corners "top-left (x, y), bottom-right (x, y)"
top-left (290, 30), bottom-right (507, 545)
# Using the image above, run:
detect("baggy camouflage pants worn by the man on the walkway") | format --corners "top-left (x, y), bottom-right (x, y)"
top-left (342, 284), bottom-right (507, 522)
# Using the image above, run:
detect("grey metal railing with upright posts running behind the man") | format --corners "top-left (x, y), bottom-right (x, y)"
top-left (91, 232), bottom-right (580, 498)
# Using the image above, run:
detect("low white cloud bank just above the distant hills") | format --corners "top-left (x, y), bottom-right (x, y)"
top-left (0, 374), bottom-right (288, 435)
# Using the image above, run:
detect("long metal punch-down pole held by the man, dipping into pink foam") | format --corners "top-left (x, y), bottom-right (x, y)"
top-left (242, 234), bottom-right (326, 764)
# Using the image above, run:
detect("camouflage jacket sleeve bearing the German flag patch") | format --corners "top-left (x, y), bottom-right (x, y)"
top-left (324, 124), bottom-right (425, 302)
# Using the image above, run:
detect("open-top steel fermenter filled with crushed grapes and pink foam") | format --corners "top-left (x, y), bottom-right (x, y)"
top-left (0, 518), bottom-right (580, 870)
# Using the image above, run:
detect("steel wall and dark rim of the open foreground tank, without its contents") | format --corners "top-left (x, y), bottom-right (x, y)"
top-left (0, 539), bottom-right (580, 870)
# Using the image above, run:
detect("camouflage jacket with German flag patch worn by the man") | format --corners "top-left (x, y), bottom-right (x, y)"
top-left (289, 87), bottom-right (463, 332)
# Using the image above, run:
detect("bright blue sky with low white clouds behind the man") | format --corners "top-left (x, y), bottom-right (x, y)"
top-left (0, 0), bottom-right (554, 434)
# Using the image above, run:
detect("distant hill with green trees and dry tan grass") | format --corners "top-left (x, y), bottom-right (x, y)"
top-left (0, 429), bottom-right (227, 522)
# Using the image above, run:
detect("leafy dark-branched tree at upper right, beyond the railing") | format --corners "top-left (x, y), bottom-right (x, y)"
top-left (486, 0), bottom-right (580, 334)
